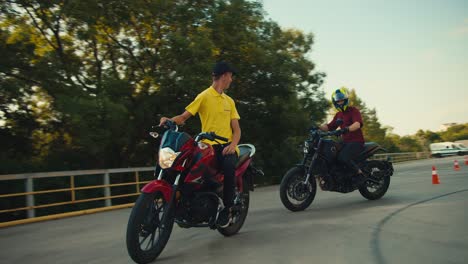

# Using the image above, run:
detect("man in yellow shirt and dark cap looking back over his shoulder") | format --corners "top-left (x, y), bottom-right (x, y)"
top-left (160, 61), bottom-right (241, 228)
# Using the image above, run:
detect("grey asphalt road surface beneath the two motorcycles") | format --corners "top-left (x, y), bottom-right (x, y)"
top-left (0, 157), bottom-right (468, 264)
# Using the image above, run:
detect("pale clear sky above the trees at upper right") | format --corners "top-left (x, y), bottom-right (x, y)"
top-left (260, 0), bottom-right (468, 136)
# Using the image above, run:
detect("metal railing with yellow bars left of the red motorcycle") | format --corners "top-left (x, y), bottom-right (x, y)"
top-left (0, 167), bottom-right (154, 228)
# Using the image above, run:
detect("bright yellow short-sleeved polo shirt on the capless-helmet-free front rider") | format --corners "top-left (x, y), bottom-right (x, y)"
top-left (185, 86), bottom-right (240, 144)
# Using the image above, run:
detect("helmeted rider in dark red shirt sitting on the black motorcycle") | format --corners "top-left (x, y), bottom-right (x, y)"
top-left (320, 88), bottom-right (364, 178)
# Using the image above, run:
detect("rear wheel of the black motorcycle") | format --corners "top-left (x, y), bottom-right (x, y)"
top-left (359, 160), bottom-right (390, 200)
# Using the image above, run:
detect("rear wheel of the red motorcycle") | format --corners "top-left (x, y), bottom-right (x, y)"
top-left (217, 181), bottom-right (250, 236)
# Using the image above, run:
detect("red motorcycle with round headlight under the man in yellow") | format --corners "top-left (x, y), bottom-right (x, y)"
top-left (127, 121), bottom-right (263, 263)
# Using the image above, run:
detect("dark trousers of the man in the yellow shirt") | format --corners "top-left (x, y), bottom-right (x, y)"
top-left (213, 144), bottom-right (237, 207)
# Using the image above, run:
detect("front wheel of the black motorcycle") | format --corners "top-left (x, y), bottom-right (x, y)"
top-left (280, 167), bottom-right (317, 212)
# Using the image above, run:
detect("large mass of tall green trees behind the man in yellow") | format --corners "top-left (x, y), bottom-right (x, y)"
top-left (0, 0), bottom-right (328, 185)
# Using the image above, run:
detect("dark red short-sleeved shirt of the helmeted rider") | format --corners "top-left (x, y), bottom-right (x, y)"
top-left (327, 106), bottom-right (364, 143)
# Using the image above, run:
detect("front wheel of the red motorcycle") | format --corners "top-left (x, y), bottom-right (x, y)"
top-left (127, 192), bottom-right (174, 263)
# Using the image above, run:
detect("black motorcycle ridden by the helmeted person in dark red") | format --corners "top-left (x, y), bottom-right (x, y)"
top-left (280, 122), bottom-right (393, 212)
